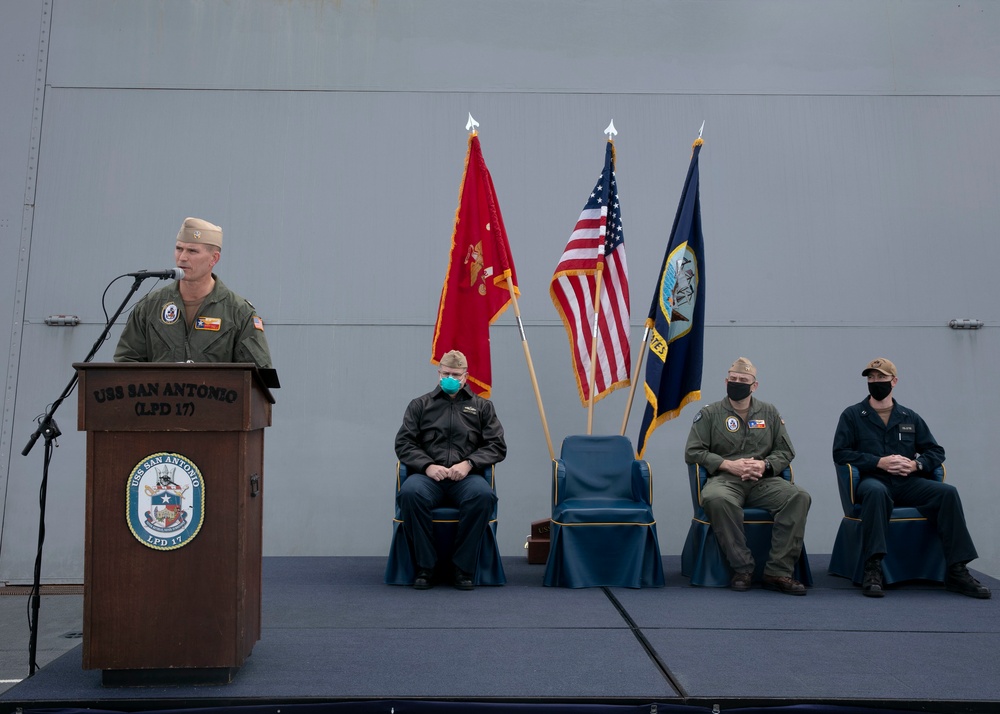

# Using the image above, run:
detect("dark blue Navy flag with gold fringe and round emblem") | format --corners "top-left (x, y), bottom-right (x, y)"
top-left (638, 139), bottom-right (705, 458)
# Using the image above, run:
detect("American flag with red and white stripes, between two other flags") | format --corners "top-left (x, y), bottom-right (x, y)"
top-left (549, 140), bottom-right (630, 405)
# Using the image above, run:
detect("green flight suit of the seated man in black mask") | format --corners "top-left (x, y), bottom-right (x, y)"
top-left (684, 397), bottom-right (812, 577)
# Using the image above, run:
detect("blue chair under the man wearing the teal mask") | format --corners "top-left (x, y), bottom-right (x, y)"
top-left (385, 463), bottom-right (507, 585)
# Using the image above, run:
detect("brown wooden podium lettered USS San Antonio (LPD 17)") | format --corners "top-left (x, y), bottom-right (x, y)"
top-left (73, 363), bottom-right (274, 684)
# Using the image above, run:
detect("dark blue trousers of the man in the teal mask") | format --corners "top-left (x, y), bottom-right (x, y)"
top-left (396, 473), bottom-right (497, 575)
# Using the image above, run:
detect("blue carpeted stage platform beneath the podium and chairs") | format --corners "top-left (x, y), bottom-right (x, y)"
top-left (0, 555), bottom-right (1000, 714)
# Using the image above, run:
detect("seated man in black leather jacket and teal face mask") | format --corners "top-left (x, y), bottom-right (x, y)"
top-left (396, 350), bottom-right (507, 590)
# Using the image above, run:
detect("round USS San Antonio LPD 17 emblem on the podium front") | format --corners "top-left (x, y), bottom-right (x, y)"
top-left (126, 452), bottom-right (205, 550)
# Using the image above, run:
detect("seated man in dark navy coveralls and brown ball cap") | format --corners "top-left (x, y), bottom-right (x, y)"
top-left (833, 357), bottom-right (990, 598)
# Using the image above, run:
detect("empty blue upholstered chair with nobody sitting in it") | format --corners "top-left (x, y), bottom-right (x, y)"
top-left (544, 436), bottom-right (663, 588)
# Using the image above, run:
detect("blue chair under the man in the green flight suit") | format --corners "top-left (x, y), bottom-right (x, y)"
top-left (681, 464), bottom-right (813, 588)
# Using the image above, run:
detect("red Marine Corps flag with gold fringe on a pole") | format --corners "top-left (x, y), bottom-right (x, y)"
top-left (431, 128), bottom-right (520, 397)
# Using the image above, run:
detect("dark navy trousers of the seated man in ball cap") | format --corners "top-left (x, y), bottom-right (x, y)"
top-left (857, 476), bottom-right (979, 565)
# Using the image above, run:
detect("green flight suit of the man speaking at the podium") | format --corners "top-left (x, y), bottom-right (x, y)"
top-left (115, 276), bottom-right (272, 368)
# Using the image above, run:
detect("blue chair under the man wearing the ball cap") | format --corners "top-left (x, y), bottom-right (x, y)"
top-left (829, 464), bottom-right (946, 585)
